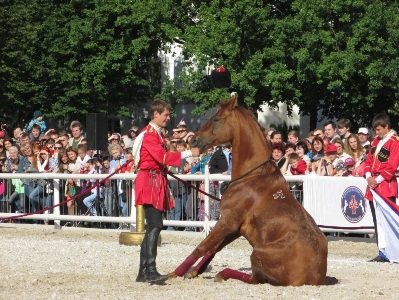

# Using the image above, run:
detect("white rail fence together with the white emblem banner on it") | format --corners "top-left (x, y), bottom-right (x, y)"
top-left (0, 173), bottom-right (374, 234)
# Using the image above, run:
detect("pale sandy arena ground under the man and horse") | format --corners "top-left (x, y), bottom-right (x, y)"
top-left (0, 224), bottom-right (399, 300)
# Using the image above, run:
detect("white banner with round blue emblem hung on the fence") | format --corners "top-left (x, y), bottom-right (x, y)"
top-left (303, 176), bottom-right (374, 229)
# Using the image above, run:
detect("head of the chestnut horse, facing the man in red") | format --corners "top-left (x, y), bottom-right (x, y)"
top-left (190, 96), bottom-right (238, 152)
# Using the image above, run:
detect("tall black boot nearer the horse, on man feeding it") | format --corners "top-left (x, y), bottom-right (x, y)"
top-left (146, 228), bottom-right (168, 282)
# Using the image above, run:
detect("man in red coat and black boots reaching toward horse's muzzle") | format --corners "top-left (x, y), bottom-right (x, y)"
top-left (133, 100), bottom-right (199, 282)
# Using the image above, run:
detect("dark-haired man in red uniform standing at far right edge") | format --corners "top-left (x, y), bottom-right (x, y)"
top-left (364, 113), bottom-right (399, 262)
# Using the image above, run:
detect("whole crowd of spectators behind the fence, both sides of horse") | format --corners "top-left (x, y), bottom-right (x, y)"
top-left (0, 111), bottom-right (371, 229)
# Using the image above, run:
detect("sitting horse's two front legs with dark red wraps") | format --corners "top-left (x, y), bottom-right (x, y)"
top-left (169, 224), bottom-right (240, 278)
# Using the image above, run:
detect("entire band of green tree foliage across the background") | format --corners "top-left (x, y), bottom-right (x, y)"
top-left (0, 0), bottom-right (399, 127)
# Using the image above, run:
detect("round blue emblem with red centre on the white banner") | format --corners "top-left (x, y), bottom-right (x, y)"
top-left (341, 186), bottom-right (366, 223)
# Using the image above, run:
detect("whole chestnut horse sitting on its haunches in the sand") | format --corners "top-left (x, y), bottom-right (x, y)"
top-left (169, 97), bottom-right (327, 286)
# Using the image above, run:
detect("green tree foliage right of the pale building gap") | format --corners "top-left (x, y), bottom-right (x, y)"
top-left (163, 0), bottom-right (399, 127)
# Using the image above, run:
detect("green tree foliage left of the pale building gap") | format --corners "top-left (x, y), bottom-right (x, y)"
top-left (0, 0), bottom-right (183, 127)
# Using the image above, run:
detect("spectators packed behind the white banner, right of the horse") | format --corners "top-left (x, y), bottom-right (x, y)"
top-left (265, 119), bottom-right (372, 176)
